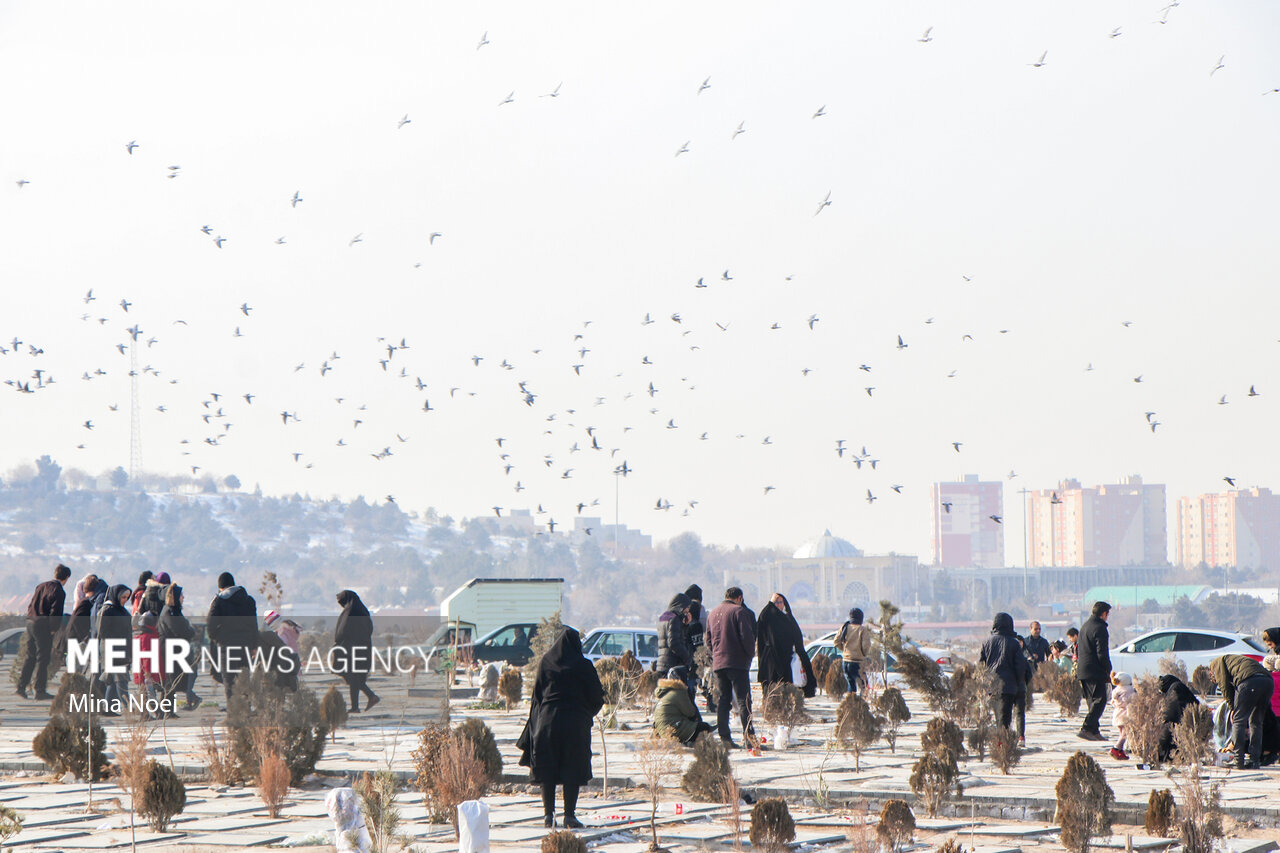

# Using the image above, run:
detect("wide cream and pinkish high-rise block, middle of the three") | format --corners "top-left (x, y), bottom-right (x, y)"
top-left (1027, 475), bottom-right (1169, 567)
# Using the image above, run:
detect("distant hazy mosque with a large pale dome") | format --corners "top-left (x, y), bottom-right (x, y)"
top-left (724, 530), bottom-right (928, 619)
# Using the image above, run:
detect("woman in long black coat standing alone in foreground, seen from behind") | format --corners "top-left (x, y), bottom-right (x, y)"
top-left (516, 628), bottom-right (604, 829)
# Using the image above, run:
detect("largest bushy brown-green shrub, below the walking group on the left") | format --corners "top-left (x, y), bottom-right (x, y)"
top-left (223, 671), bottom-right (329, 785)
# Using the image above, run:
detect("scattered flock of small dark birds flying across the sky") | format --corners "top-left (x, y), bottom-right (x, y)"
top-left (0, 0), bottom-right (1280, 534)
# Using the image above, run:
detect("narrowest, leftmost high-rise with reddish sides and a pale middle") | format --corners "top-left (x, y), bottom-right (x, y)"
top-left (929, 474), bottom-right (1005, 569)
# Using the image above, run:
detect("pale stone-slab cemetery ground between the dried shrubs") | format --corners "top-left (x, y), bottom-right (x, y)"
top-left (0, 665), bottom-right (1280, 853)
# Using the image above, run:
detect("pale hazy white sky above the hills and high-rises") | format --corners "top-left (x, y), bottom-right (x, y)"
top-left (0, 0), bottom-right (1280, 565)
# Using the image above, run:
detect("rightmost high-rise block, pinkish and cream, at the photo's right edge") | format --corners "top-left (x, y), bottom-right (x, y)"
top-left (1178, 488), bottom-right (1280, 569)
